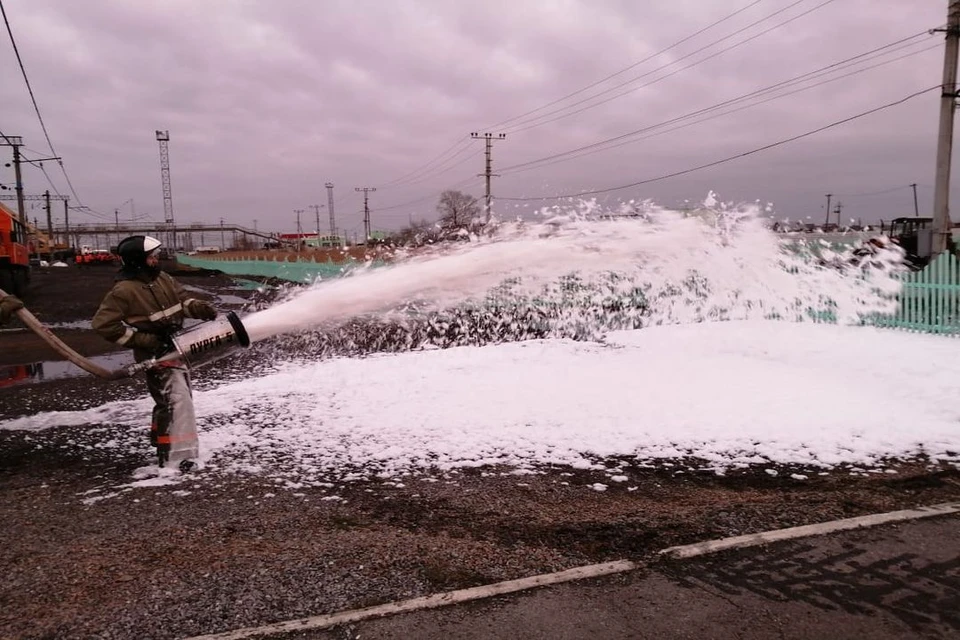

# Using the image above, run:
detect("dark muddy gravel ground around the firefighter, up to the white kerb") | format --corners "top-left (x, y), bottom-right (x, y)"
top-left (0, 267), bottom-right (960, 639)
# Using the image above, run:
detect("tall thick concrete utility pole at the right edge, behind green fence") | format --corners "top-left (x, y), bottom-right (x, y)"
top-left (932, 0), bottom-right (960, 256)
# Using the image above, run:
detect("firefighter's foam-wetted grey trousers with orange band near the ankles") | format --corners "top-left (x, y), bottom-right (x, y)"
top-left (147, 362), bottom-right (200, 467)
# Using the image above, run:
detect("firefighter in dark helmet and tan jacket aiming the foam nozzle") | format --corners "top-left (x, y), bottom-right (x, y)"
top-left (93, 235), bottom-right (217, 471)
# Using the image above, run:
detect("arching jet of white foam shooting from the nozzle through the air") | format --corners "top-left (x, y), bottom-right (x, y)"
top-left (244, 193), bottom-right (901, 341)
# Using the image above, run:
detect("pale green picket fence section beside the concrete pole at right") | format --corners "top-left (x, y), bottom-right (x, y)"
top-left (871, 252), bottom-right (960, 336)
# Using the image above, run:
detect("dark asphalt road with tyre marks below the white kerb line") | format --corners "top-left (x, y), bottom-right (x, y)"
top-left (296, 516), bottom-right (960, 640)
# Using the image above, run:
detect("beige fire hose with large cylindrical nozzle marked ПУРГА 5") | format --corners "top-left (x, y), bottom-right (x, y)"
top-left (0, 289), bottom-right (250, 380)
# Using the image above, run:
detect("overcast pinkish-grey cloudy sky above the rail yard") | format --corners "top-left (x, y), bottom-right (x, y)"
top-left (0, 0), bottom-right (960, 234)
